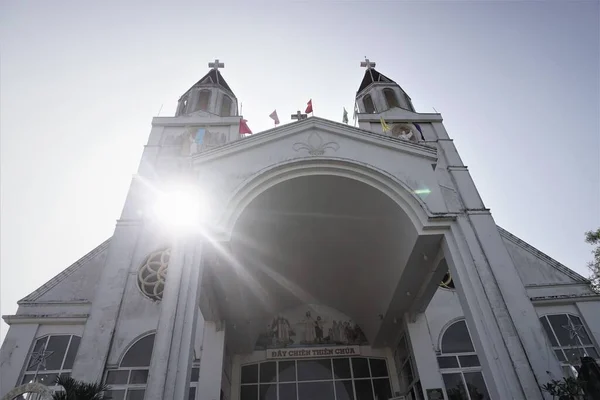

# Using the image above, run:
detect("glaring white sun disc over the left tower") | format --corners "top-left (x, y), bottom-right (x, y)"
top-left (154, 187), bottom-right (206, 229)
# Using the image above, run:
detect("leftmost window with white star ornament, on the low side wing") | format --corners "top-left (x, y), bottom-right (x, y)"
top-left (21, 335), bottom-right (81, 391)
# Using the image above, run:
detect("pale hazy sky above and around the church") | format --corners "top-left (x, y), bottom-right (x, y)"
top-left (0, 0), bottom-right (600, 337)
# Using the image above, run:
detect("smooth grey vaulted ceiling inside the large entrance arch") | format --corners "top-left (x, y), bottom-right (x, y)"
top-left (214, 176), bottom-right (440, 351)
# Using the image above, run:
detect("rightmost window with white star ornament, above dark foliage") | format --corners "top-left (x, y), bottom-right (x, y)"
top-left (540, 314), bottom-right (600, 376)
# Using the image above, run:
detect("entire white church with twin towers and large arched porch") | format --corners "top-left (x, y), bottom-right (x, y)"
top-left (0, 60), bottom-right (600, 400)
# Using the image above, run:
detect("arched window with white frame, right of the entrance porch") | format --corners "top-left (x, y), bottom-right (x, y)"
top-left (437, 320), bottom-right (490, 400)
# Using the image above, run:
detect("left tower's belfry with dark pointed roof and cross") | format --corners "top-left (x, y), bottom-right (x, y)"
top-left (175, 59), bottom-right (238, 117)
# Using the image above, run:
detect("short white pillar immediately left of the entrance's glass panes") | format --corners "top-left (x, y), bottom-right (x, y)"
top-left (197, 321), bottom-right (225, 400)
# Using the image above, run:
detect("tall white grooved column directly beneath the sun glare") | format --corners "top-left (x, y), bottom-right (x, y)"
top-left (145, 235), bottom-right (204, 400)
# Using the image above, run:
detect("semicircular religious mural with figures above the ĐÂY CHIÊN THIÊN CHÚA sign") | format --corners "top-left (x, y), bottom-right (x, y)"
top-left (255, 305), bottom-right (367, 350)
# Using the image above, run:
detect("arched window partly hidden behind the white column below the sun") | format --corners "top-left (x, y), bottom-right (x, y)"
top-left (105, 334), bottom-right (199, 400)
